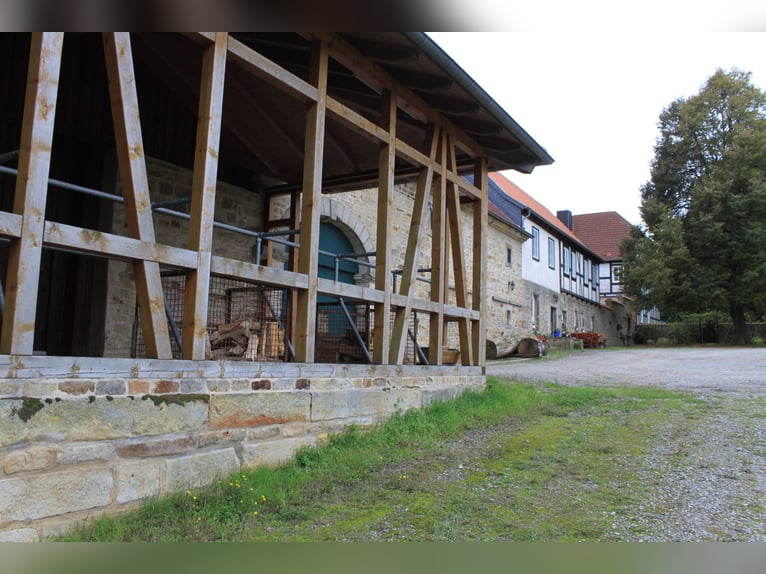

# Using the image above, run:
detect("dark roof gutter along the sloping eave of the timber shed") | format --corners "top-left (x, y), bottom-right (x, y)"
top-left (402, 32), bottom-right (554, 171)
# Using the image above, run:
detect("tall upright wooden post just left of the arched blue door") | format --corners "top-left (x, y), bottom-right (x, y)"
top-left (295, 41), bottom-right (328, 363)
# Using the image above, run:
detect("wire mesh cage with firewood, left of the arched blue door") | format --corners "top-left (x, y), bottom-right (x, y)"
top-left (132, 272), bottom-right (288, 361)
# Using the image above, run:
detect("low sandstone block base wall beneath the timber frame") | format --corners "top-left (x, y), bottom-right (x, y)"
top-left (0, 357), bottom-right (484, 541)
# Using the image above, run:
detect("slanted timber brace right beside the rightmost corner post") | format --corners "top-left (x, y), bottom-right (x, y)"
top-left (446, 136), bottom-right (473, 365)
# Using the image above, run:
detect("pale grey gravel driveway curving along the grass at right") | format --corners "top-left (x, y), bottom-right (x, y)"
top-left (487, 348), bottom-right (766, 541)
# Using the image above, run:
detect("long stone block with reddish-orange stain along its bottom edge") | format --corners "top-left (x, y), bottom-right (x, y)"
top-left (210, 391), bottom-right (311, 428)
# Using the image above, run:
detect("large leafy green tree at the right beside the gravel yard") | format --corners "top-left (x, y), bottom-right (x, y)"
top-left (622, 69), bottom-right (766, 344)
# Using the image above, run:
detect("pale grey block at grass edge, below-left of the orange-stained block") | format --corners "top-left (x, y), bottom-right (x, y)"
top-left (165, 448), bottom-right (239, 492)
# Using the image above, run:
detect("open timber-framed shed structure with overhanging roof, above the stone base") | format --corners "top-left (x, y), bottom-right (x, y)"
top-left (0, 33), bottom-right (552, 375)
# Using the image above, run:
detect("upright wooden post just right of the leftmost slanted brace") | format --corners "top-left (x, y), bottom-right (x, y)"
top-left (181, 32), bottom-right (229, 361)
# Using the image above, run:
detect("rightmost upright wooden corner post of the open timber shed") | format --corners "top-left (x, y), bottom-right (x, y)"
top-left (471, 158), bottom-right (489, 367)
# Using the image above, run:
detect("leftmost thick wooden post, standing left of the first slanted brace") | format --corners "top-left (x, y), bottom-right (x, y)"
top-left (0, 33), bottom-right (64, 355)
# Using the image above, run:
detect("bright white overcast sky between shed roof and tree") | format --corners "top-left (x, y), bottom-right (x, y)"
top-left (429, 31), bottom-right (766, 224)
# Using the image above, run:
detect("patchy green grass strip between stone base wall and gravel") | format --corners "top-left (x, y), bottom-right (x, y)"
top-left (66, 377), bottom-right (701, 541)
